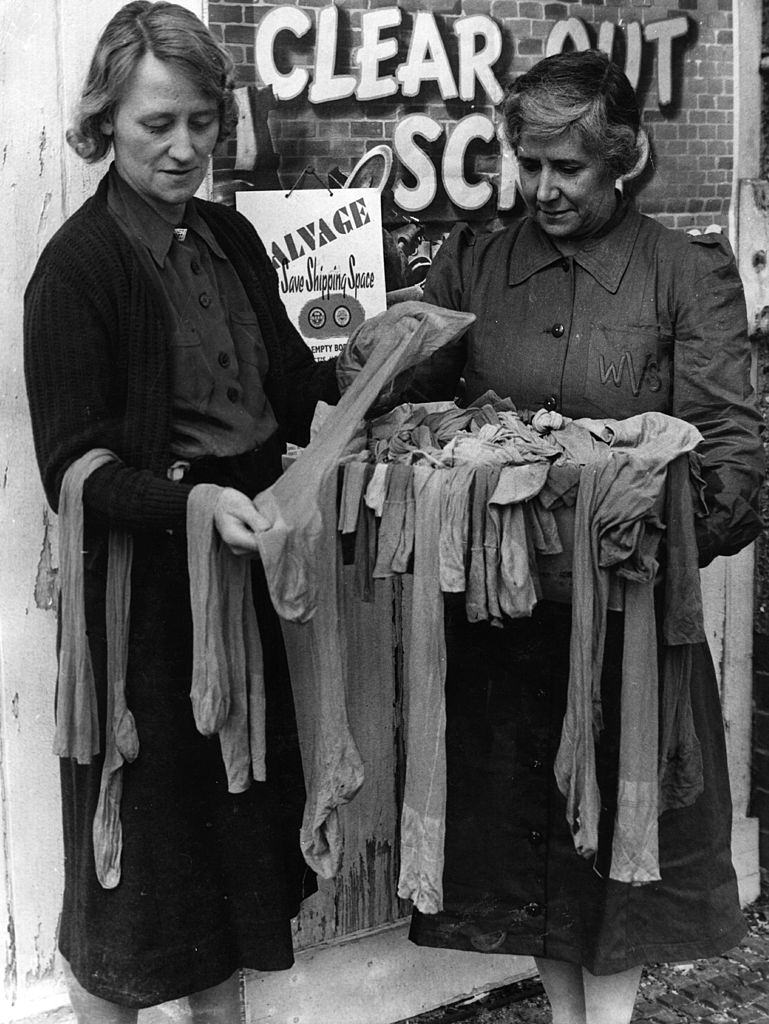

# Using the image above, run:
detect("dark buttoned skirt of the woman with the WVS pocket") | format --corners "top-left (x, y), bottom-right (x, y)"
top-left (411, 598), bottom-right (745, 974)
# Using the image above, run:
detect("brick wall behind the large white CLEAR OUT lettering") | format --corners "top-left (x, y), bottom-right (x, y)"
top-left (209, 0), bottom-right (732, 234)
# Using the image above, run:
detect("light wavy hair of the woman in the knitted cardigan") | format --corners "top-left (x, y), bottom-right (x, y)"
top-left (67, 0), bottom-right (238, 164)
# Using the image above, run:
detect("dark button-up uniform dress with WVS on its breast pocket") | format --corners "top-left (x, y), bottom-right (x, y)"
top-left (411, 203), bottom-right (762, 974)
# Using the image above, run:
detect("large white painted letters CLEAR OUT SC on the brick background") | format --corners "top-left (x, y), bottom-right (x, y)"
top-left (237, 5), bottom-right (690, 214)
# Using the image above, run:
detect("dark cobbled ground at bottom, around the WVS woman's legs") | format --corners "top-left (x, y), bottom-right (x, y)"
top-left (401, 885), bottom-right (769, 1024)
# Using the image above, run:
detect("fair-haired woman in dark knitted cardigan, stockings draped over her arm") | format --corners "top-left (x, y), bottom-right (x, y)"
top-left (25, 0), bottom-right (346, 1024)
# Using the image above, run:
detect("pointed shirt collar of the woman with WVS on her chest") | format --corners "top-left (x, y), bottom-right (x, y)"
top-left (508, 193), bottom-right (641, 293)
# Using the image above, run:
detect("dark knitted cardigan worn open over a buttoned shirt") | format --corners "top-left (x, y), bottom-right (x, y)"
top-left (25, 168), bottom-right (339, 529)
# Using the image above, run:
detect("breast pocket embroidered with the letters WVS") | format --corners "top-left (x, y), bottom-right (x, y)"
top-left (584, 322), bottom-right (673, 419)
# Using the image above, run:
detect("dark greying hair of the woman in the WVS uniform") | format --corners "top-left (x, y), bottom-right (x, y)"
top-left (502, 50), bottom-right (645, 178)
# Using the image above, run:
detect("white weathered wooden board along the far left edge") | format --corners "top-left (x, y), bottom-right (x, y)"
top-left (0, 0), bottom-right (71, 1018)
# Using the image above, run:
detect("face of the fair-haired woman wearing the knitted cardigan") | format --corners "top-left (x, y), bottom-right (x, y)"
top-left (102, 53), bottom-right (219, 223)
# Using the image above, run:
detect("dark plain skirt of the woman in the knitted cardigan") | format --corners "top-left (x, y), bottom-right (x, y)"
top-left (59, 450), bottom-right (314, 1008)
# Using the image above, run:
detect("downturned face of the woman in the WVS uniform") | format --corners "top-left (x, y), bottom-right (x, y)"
top-left (517, 131), bottom-right (615, 241)
